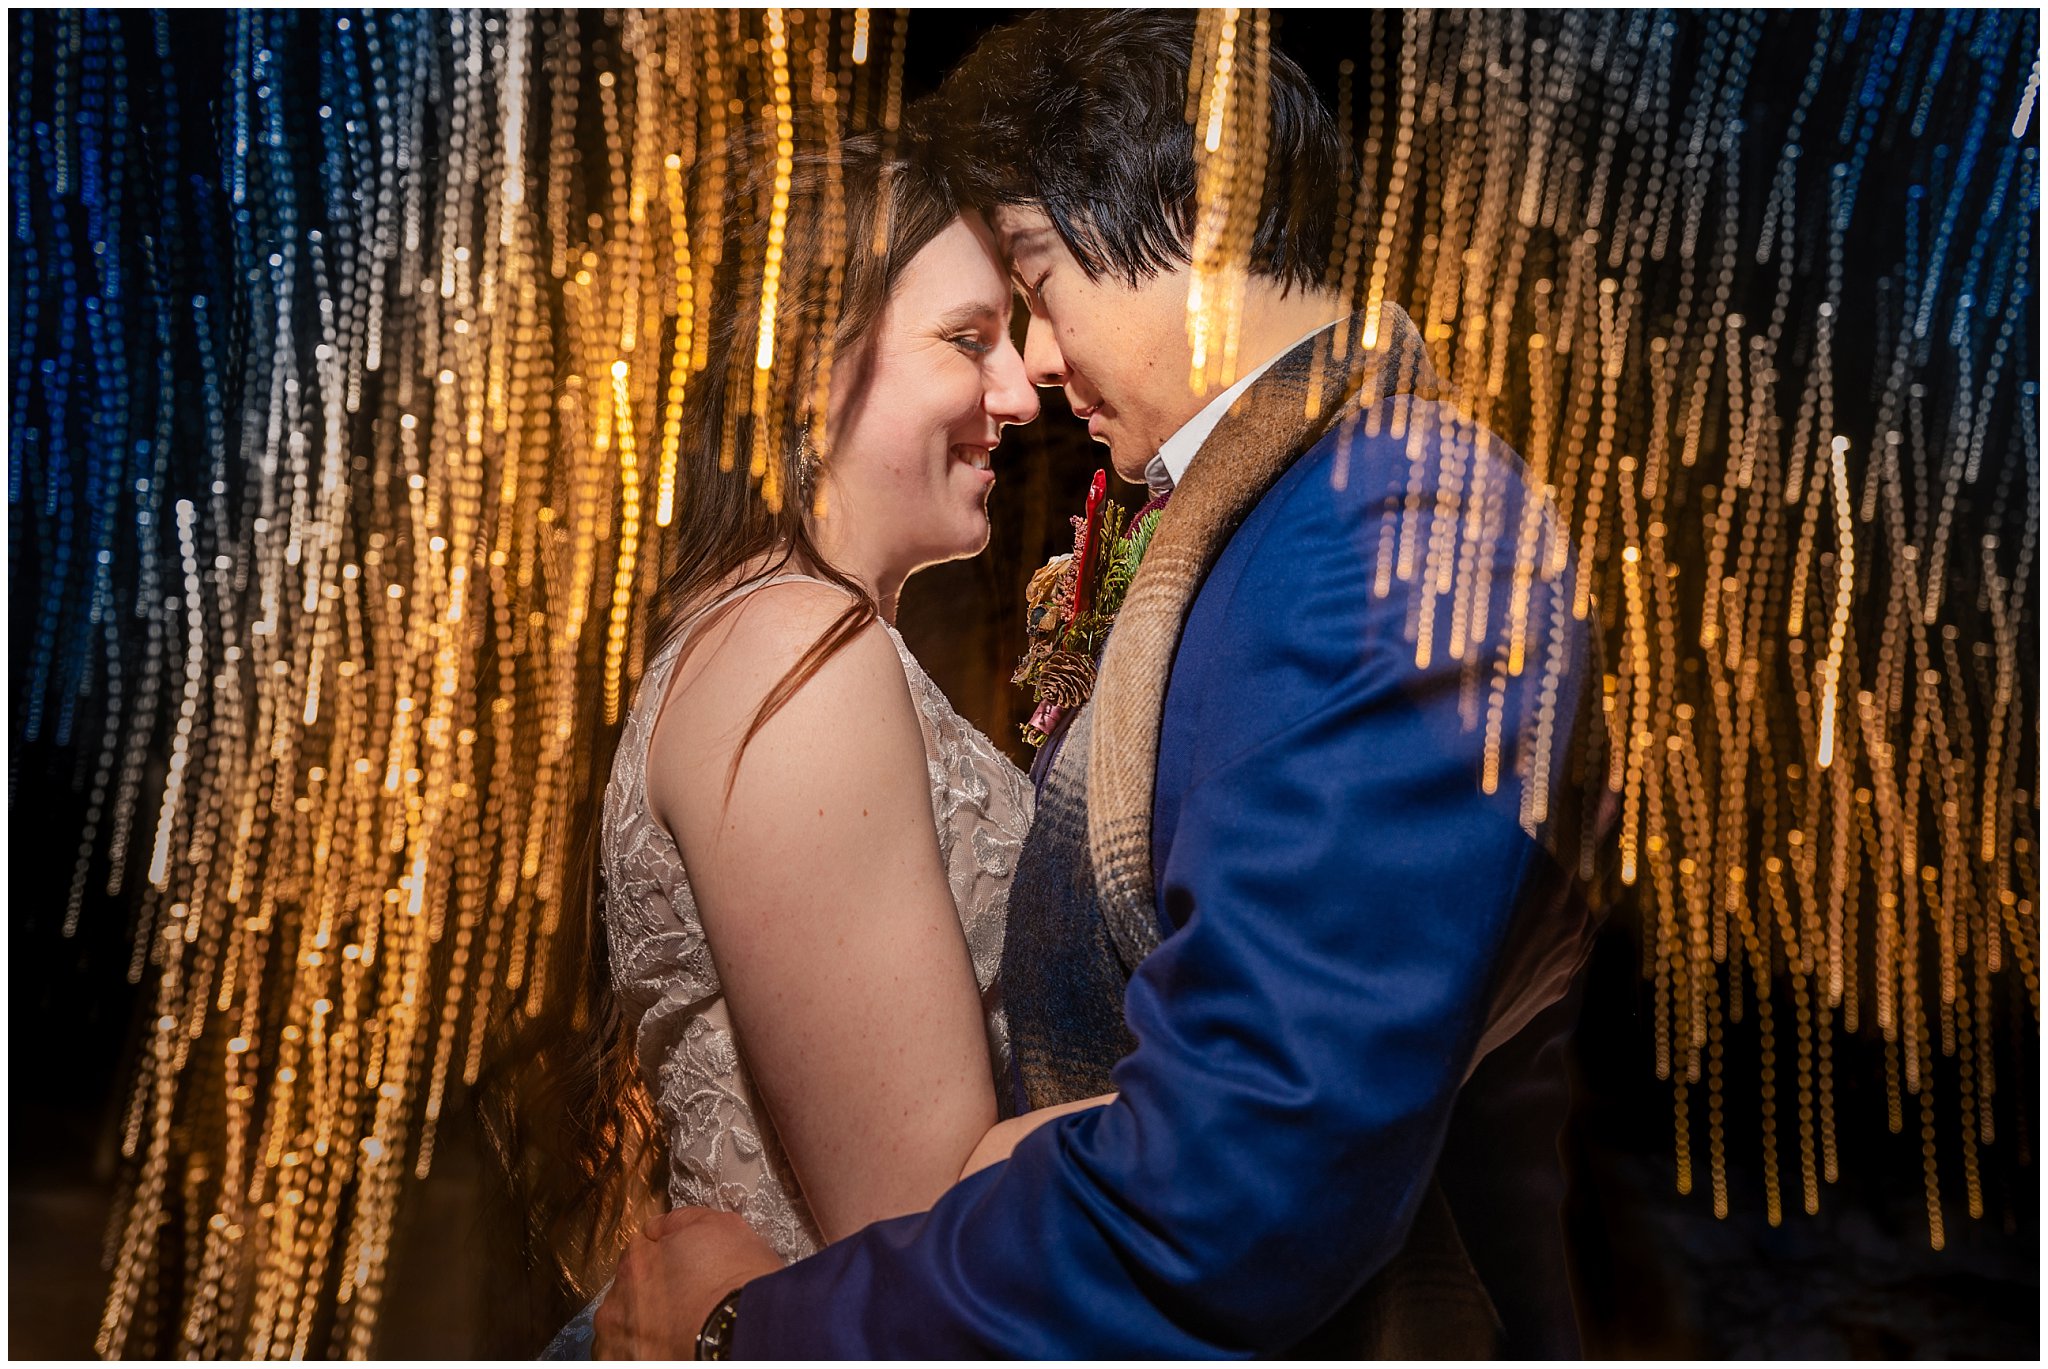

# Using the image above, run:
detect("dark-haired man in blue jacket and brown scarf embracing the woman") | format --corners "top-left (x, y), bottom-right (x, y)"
top-left (598, 10), bottom-right (1599, 1359)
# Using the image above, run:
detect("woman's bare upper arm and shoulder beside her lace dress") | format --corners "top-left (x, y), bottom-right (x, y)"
top-left (647, 582), bottom-right (995, 1240)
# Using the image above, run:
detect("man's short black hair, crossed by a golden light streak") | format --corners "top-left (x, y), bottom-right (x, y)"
top-left (918, 10), bottom-right (1352, 289)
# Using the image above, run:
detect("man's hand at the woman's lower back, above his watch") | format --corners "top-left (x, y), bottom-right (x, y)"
top-left (592, 1207), bottom-right (782, 1359)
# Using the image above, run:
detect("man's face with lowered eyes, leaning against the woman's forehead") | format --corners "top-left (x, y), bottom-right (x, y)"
top-left (993, 205), bottom-right (1208, 484)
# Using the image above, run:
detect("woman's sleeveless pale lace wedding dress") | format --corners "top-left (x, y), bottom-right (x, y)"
top-left (547, 574), bottom-right (1032, 1359)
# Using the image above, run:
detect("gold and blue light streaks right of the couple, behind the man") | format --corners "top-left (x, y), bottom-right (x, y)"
top-left (1188, 10), bottom-right (2040, 1248)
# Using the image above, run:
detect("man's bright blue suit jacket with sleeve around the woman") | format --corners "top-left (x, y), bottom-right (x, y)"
top-left (735, 398), bottom-right (1597, 1359)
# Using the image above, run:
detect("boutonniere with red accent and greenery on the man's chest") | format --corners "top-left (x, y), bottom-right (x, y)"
top-left (1010, 471), bottom-right (1159, 746)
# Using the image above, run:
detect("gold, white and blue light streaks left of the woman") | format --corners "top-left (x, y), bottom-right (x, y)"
top-left (10, 10), bottom-right (872, 1357)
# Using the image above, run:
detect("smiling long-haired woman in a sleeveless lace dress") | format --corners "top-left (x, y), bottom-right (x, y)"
top-left (498, 128), bottom-right (1087, 1355)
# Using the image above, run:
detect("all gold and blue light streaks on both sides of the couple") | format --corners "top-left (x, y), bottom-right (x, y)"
top-left (8, 10), bottom-right (2040, 1357)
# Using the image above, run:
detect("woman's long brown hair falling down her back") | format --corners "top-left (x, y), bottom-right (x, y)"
top-left (477, 120), bottom-right (958, 1299)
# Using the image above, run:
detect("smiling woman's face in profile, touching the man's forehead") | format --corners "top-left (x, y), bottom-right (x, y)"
top-left (825, 213), bottom-right (1038, 574)
